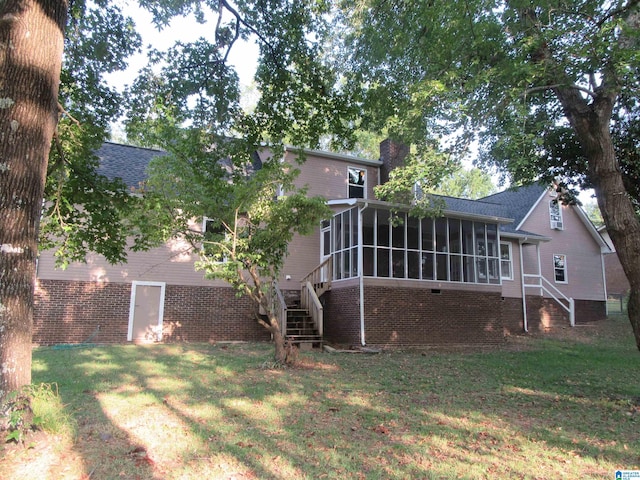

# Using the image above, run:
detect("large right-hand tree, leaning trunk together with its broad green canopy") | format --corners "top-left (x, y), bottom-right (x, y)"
top-left (335, 0), bottom-right (640, 349)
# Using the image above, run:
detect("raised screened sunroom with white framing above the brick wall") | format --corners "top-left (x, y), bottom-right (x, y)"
top-left (322, 202), bottom-right (511, 285)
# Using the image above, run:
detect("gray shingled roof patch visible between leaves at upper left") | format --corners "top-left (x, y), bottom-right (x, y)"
top-left (96, 142), bottom-right (166, 187)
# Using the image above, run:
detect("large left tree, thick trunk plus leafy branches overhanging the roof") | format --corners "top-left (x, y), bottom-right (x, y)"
top-left (0, 0), bottom-right (353, 397)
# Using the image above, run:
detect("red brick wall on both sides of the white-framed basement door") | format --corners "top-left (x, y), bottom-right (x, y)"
top-left (33, 280), bottom-right (270, 345)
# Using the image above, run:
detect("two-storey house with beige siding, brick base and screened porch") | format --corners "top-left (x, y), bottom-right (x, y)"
top-left (34, 141), bottom-right (609, 346)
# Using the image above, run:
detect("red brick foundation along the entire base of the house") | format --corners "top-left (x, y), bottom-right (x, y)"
top-left (33, 280), bottom-right (606, 346)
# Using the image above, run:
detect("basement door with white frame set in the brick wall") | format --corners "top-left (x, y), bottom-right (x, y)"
top-left (127, 282), bottom-right (166, 343)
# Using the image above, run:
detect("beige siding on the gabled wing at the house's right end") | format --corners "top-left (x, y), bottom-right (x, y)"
top-left (521, 196), bottom-right (605, 300)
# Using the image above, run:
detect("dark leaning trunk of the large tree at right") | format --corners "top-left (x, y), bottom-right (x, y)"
top-left (555, 85), bottom-right (640, 350)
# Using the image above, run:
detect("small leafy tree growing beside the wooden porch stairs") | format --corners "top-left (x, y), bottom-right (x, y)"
top-left (145, 140), bottom-right (331, 363)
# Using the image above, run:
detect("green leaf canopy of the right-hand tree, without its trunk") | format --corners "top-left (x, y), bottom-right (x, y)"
top-left (338, 0), bottom-right (639, 189)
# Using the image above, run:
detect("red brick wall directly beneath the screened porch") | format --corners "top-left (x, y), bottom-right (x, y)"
top-left (325, 286), bottom-right (504, 346)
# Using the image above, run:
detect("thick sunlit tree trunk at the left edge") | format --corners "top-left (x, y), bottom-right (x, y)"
top-left (0, 0), bottom-right (68, 399)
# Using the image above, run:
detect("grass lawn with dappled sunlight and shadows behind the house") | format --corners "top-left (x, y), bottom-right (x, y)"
top-left (0, 317), bottom-right (640, 480)
